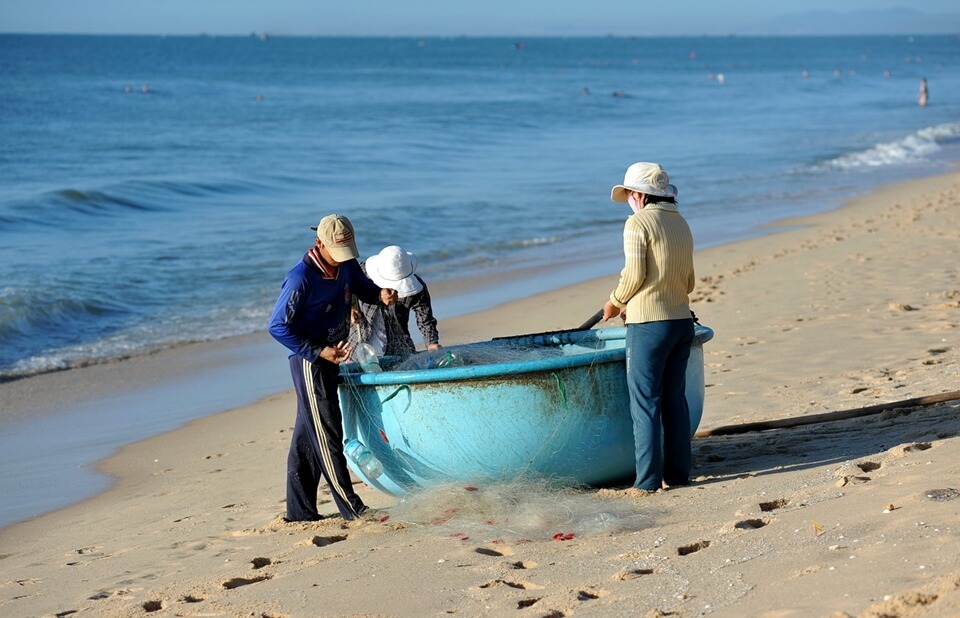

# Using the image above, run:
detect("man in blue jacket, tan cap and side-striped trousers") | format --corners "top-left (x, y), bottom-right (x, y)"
top-left (269, 215), bottom-right (397, 521)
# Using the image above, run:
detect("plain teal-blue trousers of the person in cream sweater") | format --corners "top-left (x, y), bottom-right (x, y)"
top-left (626, 320), bottom-right (694, 491)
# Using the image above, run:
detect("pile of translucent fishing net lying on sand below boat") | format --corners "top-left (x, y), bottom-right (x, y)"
top-left (390, 478), bottom-right (653, 542)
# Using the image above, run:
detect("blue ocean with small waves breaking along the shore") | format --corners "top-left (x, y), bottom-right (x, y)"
top-left (0, 34), bottom-right (960, 525)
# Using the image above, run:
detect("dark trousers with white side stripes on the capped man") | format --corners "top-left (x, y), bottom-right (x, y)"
top-left (287, 356), bottom-right (367, 521)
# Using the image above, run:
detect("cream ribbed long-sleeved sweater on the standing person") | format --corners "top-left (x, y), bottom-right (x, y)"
top-left (610, 202), bottom-right (694, 324)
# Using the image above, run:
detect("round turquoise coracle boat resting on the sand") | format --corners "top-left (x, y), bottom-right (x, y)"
top-left (340, 326), bottom-right (713, 495)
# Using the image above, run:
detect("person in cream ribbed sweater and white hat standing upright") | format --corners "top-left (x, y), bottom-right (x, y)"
top-left (603, 162), bottom-right (694, 491)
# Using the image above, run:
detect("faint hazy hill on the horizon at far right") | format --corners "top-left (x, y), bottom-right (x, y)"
top-left (744, 9), bottom-right (960, 35)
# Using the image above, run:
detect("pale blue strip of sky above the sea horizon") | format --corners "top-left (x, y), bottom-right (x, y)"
top-left (0, 0), bottom-right (960, 36)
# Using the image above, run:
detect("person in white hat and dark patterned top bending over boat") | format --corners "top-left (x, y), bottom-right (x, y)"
top-left (348, 245), bottom-right (440, 356)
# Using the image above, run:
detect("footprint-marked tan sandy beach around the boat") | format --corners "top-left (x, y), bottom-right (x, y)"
top-left (0, 167), bottom-right (960, 618)
